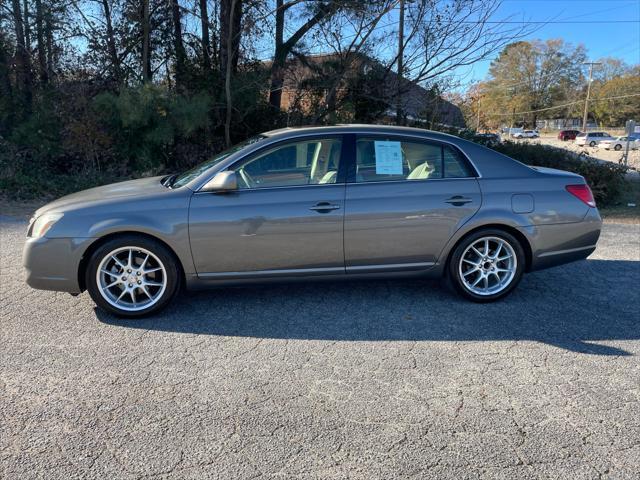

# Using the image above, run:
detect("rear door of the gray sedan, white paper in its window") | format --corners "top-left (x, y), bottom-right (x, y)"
top-left (344, 135), bottom-right (481, 273)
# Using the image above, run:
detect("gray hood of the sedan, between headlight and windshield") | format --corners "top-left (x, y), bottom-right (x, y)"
top-left (34, 176), bottom-right (169, 217)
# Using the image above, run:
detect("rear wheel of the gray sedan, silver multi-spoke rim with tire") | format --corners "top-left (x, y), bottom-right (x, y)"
top-left (448, 229), bottom-right (525, 303)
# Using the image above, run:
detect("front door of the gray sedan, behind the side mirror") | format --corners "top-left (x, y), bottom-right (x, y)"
top-left (189, 136), bottom-right (345, 279)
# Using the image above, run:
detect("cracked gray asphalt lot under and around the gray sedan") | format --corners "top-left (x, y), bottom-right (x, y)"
top-left (0, 217), bottom-right (640, 479)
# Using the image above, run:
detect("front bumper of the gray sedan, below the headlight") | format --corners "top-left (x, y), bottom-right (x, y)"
top-left (22, 237), bottom-right (95, 293)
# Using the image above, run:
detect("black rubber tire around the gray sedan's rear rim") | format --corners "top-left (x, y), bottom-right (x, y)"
top-left (447, 228), bottom-right (525, 303)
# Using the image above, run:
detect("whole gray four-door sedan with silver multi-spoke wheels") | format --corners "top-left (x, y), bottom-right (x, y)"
top-left (24, 125), bottom-right (602, 317)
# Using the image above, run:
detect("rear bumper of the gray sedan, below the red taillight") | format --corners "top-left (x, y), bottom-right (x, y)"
top-left (523, 208), bottom-right (602, 270)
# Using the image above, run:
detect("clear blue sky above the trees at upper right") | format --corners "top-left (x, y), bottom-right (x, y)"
top-left (460, 0), bottom-right (640, 82)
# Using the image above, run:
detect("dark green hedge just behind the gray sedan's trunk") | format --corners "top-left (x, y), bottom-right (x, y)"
top-left (491, 141), bottom-right (627, 206)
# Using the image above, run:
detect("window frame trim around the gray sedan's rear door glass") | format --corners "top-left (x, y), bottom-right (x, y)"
top-left (347, 132), bottom-right (482, 185)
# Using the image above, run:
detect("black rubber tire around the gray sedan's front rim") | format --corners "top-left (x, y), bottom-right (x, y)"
top-left (85, 234), bottom-right (182, 318)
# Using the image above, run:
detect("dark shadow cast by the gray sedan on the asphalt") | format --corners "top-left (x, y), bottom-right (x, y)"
top-left (96, 260), bottom-right (640, 355)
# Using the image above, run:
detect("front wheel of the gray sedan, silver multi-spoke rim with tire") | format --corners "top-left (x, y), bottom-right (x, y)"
top-left (86, 235), bottom-right (180, 318)
